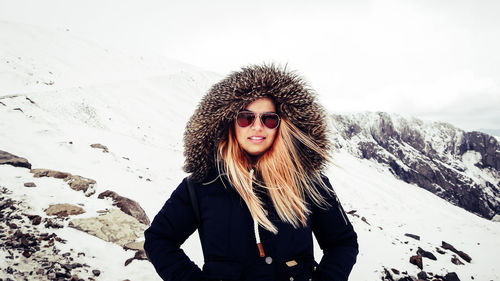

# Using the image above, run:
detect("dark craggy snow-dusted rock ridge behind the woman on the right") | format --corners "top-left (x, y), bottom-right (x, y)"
top-left (331, 112), bottom-right (500, 219)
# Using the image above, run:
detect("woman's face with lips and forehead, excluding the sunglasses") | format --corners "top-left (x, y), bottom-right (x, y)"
top-left (234, 98), bottom-right (278, 156)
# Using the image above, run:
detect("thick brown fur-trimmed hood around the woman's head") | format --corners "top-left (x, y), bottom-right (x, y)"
top-left (184, 65), bottom-right (330, 181)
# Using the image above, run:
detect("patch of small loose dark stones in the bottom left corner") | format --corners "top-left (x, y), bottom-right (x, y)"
top-left (0, 185), bottom-right (98, 281)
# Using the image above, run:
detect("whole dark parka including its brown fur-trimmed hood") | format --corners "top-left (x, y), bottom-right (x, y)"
top-left (144, 66), bottom-right (358, 281)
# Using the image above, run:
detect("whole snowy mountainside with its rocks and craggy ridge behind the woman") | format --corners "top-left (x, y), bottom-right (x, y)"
top-left (0, 22), bottom-right (500, 281)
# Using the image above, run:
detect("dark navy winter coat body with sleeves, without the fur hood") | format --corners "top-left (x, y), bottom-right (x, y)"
top-left (144, 173), bottom-right (358, 281)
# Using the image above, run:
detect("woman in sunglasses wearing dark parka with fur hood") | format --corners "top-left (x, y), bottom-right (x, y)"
top-left (144, 65), bottom-right (358, 281)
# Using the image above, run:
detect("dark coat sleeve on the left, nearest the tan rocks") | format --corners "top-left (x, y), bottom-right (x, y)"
top-left (144, 179), bottom-right (201, 281)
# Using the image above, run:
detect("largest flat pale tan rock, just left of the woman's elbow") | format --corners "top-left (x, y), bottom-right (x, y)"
top-left (69, 209), bottom-right (147, 247)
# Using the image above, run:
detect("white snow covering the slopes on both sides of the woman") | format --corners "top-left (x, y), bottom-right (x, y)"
top-left (0, 21), bottom-right (500, 281)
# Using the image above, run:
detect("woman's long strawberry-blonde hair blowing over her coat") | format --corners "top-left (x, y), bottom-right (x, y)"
top-left (217, 117), bottom-right (330, 233)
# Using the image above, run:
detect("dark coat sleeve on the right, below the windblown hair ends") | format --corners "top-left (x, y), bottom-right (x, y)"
top-left (311, 174), bottom-right (358, 281)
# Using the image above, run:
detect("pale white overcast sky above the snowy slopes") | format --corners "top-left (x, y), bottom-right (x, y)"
top-left (0, 0), bottom-right (500, 130)
